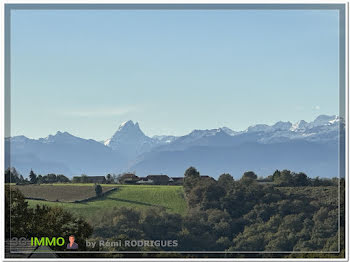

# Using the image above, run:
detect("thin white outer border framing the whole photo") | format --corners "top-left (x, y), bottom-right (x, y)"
top-left (0, 0), bottom-right (350, 261)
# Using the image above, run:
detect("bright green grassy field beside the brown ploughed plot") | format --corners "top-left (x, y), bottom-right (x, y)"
top-left (28, 184), bottom-right (187, 219)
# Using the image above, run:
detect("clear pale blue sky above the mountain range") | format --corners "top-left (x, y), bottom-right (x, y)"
top-left (11, 10), bottom-right (339, 140)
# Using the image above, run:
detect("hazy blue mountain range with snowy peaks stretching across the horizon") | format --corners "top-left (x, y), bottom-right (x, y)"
top-left (5, 115), bottom-right (343, 178)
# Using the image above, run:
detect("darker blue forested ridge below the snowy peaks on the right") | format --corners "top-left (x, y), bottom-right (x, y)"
top-left (129, 140), bottom-right (338, 178)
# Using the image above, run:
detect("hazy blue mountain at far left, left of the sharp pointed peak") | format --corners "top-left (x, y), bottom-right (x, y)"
top-left (6, 132), bottom-right (126, 176)
